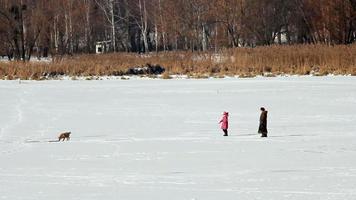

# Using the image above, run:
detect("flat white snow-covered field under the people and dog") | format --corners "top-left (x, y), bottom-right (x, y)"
top-left (0, 77), bottom-right (356, 200)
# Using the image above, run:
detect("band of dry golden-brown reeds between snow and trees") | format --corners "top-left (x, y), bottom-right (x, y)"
top-left (0, 45), bottom-right (356, 80)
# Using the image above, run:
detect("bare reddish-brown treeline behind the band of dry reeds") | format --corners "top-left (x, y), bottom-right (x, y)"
top-left (0, 0), bottom-right (356, 60)
